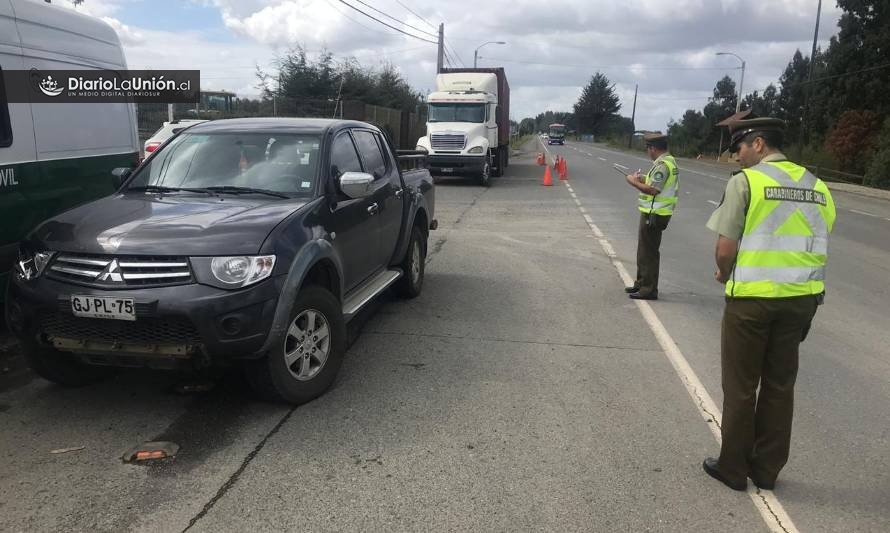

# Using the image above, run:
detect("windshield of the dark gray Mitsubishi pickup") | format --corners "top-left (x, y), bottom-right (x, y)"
top-left (127, 133), bottom-right (320, 195)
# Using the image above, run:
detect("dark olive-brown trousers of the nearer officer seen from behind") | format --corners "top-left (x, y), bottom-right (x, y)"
top-left (718, 296), bottom-right (817, 483)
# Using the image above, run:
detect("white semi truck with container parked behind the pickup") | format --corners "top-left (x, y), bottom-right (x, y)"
top-left (417, 68), bottom-right (510, 186)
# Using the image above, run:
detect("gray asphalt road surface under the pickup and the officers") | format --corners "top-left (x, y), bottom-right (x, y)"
top-left (0, 139), bottom-right (890, 531)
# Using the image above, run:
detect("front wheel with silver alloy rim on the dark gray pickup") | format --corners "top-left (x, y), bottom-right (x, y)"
top-left (247, 286), bottom-right (346, 405)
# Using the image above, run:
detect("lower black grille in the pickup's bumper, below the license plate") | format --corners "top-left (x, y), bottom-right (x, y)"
top-left (40, 313), bottom-right (201, 345)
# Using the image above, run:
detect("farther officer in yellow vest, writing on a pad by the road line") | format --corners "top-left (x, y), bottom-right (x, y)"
top-left (624, 133), bottom-right (680, 300)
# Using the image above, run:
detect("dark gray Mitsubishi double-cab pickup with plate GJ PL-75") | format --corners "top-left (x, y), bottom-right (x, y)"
top-left (6, 118), bottom-right (436, 404)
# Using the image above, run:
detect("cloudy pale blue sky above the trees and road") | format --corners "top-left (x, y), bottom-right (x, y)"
top-left (60, 0), bottom-right (841, 131)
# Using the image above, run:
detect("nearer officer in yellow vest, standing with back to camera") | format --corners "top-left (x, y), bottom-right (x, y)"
top-left (702, 118), bottom-right (835, 490)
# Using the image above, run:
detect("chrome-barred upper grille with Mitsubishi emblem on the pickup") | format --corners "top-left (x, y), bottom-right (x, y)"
top-left (47, 254), bottom-right (192, 289)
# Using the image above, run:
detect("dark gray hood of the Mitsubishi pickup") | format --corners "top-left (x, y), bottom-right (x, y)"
top-left (32, 193), bottom-right (307, 256)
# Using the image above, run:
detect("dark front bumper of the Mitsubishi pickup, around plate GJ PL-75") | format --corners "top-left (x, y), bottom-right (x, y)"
top-left (6, 276), bottom-right (286, 366)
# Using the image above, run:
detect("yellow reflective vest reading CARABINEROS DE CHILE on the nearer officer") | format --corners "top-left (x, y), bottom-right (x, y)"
top-left (726, 161), bottom-right (835, 298)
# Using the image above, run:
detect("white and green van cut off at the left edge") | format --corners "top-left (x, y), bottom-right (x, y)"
top-left (0, 0), bottom-right (139, 301)
